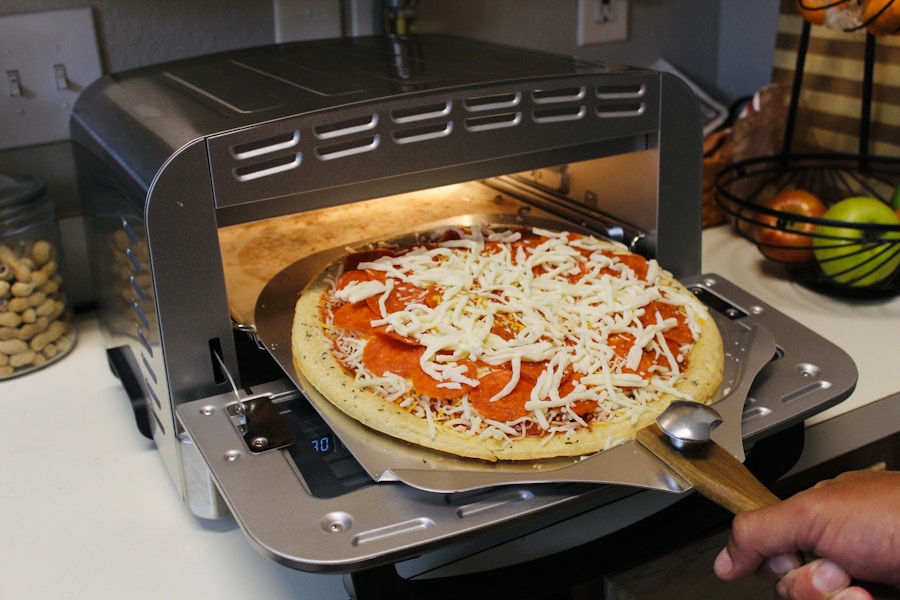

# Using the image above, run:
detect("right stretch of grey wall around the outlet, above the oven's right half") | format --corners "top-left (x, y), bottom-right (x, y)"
top-left (417, 0), bottom-right (778, 105)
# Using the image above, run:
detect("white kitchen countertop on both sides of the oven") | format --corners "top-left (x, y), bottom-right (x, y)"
top-left (0, 227), bottom-right (900, 600)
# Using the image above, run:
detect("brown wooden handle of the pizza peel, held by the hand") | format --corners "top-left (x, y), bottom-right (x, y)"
top-left (637, 423), bottom-right (781, 514)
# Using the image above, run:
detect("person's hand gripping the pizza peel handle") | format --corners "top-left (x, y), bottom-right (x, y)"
top-left (715, 471), bottom-right (900, 600)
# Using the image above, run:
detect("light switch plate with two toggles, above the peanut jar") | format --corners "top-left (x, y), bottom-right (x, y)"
top-left (0, 8), bottom-right (102, 150)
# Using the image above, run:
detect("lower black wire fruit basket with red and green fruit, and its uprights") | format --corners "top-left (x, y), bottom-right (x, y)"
top-left (716, 5), bottom-right (900, 298)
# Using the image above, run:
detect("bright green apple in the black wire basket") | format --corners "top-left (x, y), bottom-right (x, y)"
top-left (813, 196), bottom-right (900, 287)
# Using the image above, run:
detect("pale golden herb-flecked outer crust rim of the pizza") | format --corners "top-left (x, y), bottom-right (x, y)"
top-left (291, 227), bottom-right (724, 461)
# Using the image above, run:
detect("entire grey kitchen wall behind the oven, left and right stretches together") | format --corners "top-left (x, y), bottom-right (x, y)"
top-left (0, 0), bottom-right (778, 304)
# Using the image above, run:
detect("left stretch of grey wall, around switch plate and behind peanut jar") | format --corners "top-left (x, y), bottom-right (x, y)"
top-left (0, 0), bottom-right (274, 306)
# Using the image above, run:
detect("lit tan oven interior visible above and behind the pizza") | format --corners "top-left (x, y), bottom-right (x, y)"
top-left (218, 149), bottom-right (659, 329)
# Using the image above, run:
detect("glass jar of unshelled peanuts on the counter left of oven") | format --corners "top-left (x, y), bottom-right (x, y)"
top-left (0, 175), bottom-right (75, 381)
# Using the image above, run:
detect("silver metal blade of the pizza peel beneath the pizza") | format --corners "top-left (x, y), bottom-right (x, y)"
top-left (255, 219), bottom-right (775, 493)
